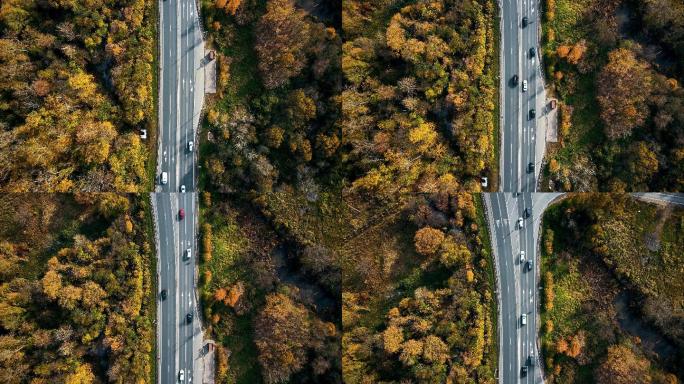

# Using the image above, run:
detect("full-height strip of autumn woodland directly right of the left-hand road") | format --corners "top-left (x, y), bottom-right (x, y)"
top-left (200, 0), bottom-right (346, 384)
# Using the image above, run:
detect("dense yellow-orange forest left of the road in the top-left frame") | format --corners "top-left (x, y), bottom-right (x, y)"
top-left (0, 0), bottom-right (157, 193)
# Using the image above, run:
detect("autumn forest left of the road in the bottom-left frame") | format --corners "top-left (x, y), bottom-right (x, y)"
top-left (0, 193), bottom-right (156, 384)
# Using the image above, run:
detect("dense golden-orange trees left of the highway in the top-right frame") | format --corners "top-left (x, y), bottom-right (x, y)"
top-left (340, 0), bottom-right (498, 195)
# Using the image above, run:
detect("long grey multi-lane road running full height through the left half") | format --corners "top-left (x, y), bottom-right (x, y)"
top-left (151, 0), bottom-right (205, 384)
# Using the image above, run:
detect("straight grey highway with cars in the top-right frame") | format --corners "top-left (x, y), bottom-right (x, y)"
top-left (499, 0), bottom-right (546, 192)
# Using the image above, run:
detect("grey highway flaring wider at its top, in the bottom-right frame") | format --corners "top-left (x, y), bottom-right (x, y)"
top-left (483, 193), bottom-right (560, 384)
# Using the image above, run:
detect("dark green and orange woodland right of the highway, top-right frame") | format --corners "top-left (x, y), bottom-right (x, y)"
top-left (542, 0), bottom-right (684, 192)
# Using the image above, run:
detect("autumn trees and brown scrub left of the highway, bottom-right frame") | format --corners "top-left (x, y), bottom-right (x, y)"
top-left (341, 191), bottom-right (498, 384)
